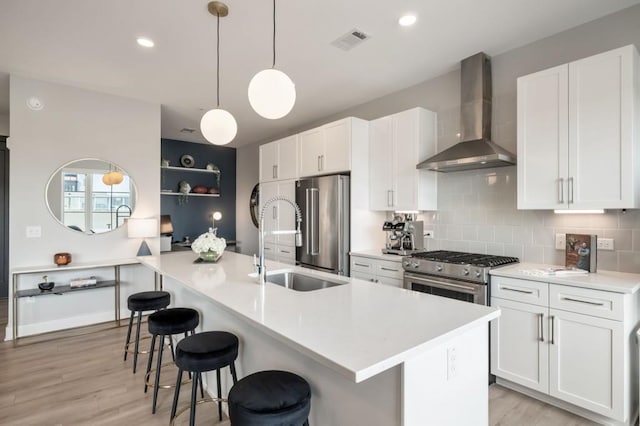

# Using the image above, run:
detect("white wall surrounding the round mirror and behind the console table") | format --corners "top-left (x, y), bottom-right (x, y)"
top-left (8, 76), bottom-right (160, 332)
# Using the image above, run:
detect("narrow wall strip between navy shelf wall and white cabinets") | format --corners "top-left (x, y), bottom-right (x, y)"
top-left (236, 144), bottom-right (260, 255)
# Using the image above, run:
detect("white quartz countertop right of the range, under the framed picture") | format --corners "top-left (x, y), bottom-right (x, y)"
top-left (490, 263), bottom-right (640, 293)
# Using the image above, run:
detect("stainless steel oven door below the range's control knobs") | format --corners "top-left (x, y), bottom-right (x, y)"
top-left (404, 272), bottom-right (487, 305)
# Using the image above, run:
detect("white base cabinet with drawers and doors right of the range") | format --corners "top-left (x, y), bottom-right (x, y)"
top-left (491, 276), bottom-right (637, 424)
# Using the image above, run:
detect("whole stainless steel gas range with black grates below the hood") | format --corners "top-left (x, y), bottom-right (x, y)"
top-left (402, 250), bottom-right (518, 305)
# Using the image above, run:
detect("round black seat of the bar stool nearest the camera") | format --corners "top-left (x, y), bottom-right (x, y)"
top-left (229, 370), bottom-right (311, 426)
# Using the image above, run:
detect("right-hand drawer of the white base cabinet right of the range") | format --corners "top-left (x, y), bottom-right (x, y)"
top-left (549, 284), bottom-right (624, 321)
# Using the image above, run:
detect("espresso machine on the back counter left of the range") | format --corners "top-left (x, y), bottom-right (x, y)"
top-left (382, 214), bottom-right (425, 256)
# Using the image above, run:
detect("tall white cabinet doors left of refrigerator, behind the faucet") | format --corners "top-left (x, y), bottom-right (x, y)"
top-left (260, 179), bottom-right (296, 264)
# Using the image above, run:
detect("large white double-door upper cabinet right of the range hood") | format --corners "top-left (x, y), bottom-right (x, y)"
top-left (518, 45), bottom-right (640, 209)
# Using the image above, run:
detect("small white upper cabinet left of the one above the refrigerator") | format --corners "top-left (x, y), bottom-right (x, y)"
top-left (260, 135), bottom-right (298, 182)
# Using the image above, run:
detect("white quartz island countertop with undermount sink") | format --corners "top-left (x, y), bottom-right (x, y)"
top-left (138, 252), bottom-right (500, 383)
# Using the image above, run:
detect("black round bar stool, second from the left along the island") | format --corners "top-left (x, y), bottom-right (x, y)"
top-left (144, 308), bottom-right (200, 414)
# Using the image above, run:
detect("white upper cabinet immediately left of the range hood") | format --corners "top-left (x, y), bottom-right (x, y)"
top-left (369, 108), bottom-right (438, 211)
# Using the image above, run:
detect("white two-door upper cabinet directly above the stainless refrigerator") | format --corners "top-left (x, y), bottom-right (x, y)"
top-left (299, 118), bottom-right (361, 176)
